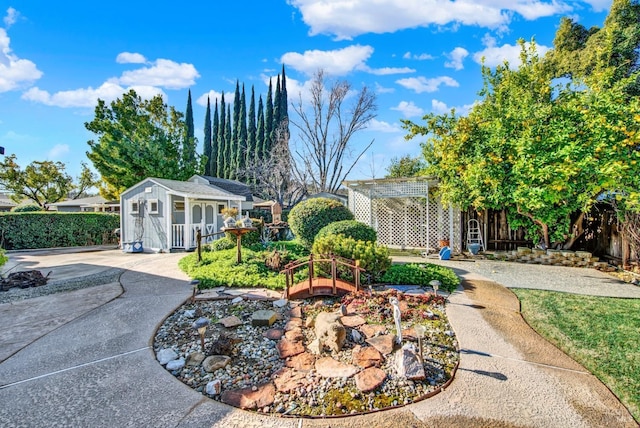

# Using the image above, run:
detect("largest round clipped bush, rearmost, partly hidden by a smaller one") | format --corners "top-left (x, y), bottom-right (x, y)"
top-left (288, 198), bottom-right (353, 248)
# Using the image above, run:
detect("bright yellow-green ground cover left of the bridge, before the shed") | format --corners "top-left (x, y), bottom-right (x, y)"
top-left (178, 248), bottom-right (285, 289)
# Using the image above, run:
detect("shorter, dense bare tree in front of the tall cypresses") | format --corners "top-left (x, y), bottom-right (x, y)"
top-left (241, 122), bottom-right (307, 207)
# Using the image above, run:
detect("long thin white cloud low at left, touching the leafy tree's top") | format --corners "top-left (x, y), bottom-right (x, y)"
top-left (22, 82), bottom-right (166, 107)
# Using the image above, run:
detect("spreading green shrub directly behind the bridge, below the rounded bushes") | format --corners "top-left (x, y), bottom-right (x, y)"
top-left (312, 235), bottom-right (391, 282)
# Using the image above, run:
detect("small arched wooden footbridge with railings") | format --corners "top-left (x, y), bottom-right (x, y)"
top-left (280, 254), bottom-right (364, 299)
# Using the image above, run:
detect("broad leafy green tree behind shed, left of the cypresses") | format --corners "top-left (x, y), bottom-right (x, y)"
top-left (85, 90), bottom-right (199, 199)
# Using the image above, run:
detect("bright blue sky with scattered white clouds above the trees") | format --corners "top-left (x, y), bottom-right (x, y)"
top-left (0, 0), bottom-right (611, 179)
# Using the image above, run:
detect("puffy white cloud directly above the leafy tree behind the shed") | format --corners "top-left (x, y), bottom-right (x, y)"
top-left (118, 59), bottom-right (200, 89)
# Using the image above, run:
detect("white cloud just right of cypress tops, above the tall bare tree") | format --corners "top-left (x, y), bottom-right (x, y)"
top-left (280, 45), bottom-right (373, 76)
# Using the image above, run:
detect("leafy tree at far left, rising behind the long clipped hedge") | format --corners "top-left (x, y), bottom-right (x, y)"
top-left (0, 154), bottom-right (97, 210)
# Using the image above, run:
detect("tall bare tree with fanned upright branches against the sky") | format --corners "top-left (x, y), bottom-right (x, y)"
top-left (291, 70), bottom-right (378, 193)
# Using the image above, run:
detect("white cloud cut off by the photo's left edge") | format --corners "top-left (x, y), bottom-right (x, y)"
top-left (0, 28), bottom-right (42, 93)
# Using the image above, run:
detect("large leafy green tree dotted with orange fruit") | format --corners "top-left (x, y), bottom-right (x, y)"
top-left (404, 41), bottom-right (640, 248)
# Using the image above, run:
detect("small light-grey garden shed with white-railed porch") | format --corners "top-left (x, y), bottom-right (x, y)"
top-left (120, 175), bottom-right (253, 252)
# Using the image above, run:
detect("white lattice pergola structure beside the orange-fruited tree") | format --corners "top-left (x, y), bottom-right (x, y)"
top-left (342, 177), bottom-right (462, 253)
